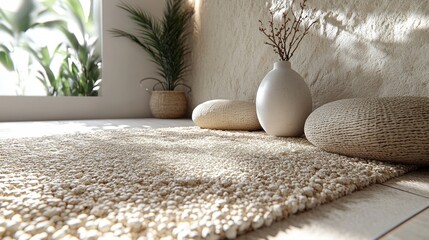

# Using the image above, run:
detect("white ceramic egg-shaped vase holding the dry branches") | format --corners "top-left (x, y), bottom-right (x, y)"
top-left (256, 61), bottom-right (313, 137)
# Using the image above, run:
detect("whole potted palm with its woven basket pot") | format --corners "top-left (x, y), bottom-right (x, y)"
top-left (111, 0), bottom-right (194, 118)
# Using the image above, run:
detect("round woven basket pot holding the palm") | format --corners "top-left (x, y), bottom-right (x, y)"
top-left (149, 91), bottom-right (188, 118)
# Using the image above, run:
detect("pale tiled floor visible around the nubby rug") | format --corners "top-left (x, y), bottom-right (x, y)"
top-left (0, 119), bottom-right (429, 240)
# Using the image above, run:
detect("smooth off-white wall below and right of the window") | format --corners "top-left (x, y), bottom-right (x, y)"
top-left (0, 0), bottom-right (165, 121)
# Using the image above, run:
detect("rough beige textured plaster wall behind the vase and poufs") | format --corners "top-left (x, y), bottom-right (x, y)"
top-left (190, 0), bottom-right (429, 107)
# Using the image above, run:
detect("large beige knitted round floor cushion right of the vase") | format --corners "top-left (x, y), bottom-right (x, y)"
top-left (304, 97), bottom-right (429, 165)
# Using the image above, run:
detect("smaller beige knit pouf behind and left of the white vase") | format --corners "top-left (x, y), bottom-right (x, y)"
top-left (192, 99), bottom-right (261, 131)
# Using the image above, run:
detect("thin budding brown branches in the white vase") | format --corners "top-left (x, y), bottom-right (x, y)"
top-left (259, 0), bottom-right (318, 61)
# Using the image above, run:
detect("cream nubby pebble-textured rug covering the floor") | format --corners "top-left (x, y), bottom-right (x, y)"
top-left (0, 127), bottom-right (412, 239)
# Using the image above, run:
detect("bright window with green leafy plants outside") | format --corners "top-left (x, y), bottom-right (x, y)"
top-left (0, 0), bottom-right (101, 96)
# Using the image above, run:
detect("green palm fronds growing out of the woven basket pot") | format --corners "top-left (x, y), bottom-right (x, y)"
top-left (111, 0), bottom-right (194, 90)
